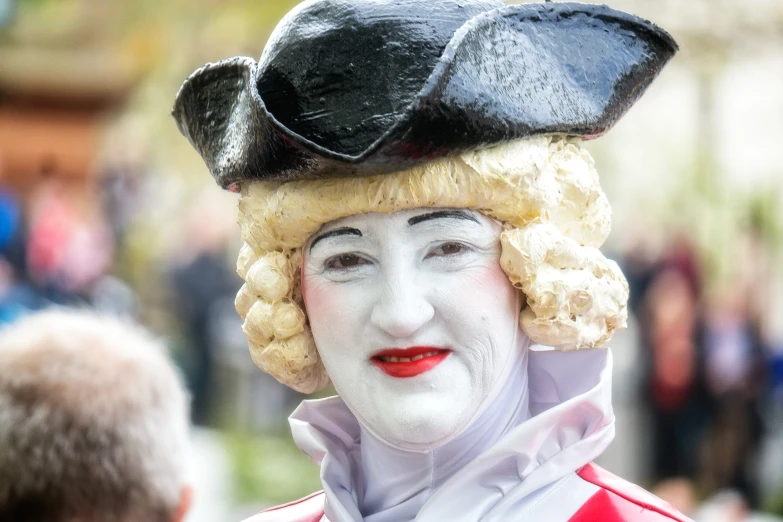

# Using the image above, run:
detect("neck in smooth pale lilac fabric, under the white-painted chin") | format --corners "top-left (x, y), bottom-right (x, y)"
top-left (358, 335), bottom-right (530, 522)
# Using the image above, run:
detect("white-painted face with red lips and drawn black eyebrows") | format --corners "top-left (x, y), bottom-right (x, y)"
top-left (302, 209), bottom-right (521, 451)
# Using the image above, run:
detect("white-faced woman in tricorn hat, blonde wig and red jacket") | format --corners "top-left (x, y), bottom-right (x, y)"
top-left (174, 0), bottom-right (686, 522)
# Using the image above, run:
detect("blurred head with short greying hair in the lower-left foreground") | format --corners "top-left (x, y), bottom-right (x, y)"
top-left (0, 310), bottom-right (191, 522)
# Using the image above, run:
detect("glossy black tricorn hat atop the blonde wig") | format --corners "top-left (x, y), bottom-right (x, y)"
top-left (173, 0), bottom-right (677, 189)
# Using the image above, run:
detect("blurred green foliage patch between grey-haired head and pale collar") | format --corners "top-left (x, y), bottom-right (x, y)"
top-left (224, 426), bottom-right (322, 505)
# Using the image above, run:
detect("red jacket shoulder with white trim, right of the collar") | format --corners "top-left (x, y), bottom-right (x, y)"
top-left (569, 463), bottom-right (690, 522)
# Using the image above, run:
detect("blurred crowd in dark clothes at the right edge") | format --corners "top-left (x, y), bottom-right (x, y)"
top-left (624, 225), bottom-right (783, 509)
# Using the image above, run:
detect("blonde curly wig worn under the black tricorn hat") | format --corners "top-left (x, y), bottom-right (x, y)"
top-left (236, 136), bottom-right (628, 393)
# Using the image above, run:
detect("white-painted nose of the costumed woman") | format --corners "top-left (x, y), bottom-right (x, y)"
top-left (370, 274), bottom-right (435, 339)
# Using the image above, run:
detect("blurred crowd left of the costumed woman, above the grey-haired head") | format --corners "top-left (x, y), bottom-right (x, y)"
top-left (0, 169), bottom-right (296, 428)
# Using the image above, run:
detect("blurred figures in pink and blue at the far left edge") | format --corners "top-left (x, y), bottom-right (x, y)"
top-left (0, 174), bottom-right (137, 323)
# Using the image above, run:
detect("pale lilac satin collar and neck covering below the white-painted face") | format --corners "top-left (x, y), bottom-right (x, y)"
top-left (290, 349), bottom-right (614, 522)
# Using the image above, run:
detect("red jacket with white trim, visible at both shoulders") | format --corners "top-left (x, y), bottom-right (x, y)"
top-left (245, 464), bottom-right (690, 522)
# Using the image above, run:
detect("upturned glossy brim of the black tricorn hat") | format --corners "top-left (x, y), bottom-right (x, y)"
top-left (173, 3), bottom-right (677, 188)
